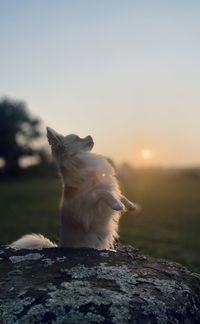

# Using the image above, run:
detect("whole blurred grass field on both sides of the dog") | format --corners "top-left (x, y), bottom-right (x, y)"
top-left (0, 171), bottom-right (200, 272)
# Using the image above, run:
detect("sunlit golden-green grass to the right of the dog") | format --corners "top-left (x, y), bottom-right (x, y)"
top-left (120, 172), bottom-right (200, 272)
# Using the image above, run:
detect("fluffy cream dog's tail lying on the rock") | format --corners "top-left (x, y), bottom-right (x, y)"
top-left (10, 234), bottom-right (57, 250)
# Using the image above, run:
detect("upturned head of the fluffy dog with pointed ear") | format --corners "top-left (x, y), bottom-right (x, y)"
top-left (47, 127), bottom-right (94, 163)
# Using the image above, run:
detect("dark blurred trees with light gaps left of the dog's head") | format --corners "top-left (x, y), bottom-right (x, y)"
top-left (0, 97), bottom-right (52, 177)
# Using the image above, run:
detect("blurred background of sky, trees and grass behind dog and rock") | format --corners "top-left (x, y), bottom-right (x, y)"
top-left (0, 0), bottom-right (200, 272)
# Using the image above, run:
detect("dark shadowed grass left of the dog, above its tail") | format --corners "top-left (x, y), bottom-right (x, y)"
top-left (0, 179), bottom-right (61, 244)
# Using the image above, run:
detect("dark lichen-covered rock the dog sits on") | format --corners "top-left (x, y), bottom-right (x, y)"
top-left (0, 246), bottom-right (200, 324)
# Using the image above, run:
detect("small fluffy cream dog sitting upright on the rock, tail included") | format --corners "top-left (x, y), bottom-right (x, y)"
top-left (11, 128), bottom-right (137, 250)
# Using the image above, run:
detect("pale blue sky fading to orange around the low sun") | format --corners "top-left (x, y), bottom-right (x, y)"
top-left (0, 0), bottom-right (200, 167)
